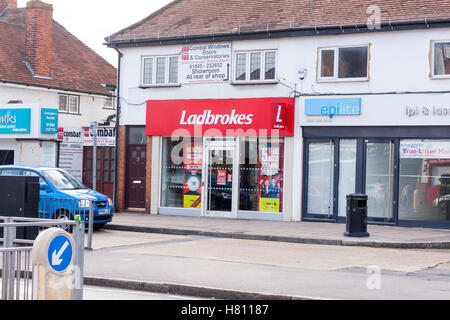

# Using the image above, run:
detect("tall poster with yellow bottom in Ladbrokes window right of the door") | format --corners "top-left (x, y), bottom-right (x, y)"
top-left (258, 144), bottom-right (283, 212)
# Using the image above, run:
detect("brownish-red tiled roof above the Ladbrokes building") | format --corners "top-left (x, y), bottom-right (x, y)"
top-left (106, 0), bottom-right (450, 42)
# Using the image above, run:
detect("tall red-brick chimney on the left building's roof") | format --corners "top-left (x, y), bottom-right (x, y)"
top-left (25, 0), bottom-right (53, 78)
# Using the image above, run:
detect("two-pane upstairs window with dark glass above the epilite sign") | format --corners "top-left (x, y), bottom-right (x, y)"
top-left (318, 46), bottom-right (369, 80)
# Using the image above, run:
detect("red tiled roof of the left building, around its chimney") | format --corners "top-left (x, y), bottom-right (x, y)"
top-left (0, 8), bottom-right (117, 95)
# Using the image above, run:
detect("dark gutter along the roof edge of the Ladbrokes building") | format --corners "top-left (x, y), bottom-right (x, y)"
top-left (105, 19), bottom-right (450, 48)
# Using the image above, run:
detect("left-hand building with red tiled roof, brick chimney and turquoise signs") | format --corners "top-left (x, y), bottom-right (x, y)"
top-left (0, 0), bottom-right (117, 197)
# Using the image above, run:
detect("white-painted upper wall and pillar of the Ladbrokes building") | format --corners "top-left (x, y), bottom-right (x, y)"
top-left (120, 28), bottom-right (450, 221)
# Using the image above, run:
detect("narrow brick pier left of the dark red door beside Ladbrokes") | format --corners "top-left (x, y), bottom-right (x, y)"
top-left (116, 126), bottom-right (127, 211)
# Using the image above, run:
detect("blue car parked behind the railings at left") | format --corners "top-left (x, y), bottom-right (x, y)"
top-left (0, 166), bottom-right (113, 229)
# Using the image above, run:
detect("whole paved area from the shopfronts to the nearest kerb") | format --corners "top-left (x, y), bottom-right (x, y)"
top-left (79, 213), bottom-right (450, 300)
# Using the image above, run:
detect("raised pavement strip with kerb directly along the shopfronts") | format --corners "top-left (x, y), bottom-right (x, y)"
top-left (106, 213), bottom-right (450, 249)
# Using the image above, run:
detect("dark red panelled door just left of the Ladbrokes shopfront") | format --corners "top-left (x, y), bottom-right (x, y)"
top-left (126, 145), bottom-right (147, 209)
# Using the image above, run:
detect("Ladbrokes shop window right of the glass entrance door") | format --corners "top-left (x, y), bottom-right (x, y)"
top-left (239, 138), bottom-right (284, 212)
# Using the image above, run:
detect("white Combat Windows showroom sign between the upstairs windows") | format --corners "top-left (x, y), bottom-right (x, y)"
top-left (180, 43), bottom-right (232, 83)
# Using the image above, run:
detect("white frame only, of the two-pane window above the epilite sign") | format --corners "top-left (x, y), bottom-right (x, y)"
top-left (316, 44), bottom-right (370, 82)
